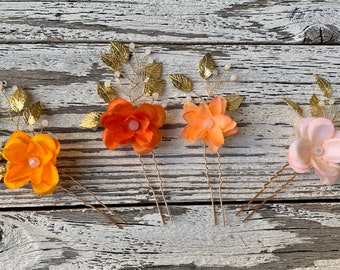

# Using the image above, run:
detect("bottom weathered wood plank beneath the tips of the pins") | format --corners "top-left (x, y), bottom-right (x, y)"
top-left (0, 203), bottom-right (340, 270)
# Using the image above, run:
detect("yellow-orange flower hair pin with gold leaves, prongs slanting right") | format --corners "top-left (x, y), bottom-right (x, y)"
top-left (0, 82), bottom-right (125, 228)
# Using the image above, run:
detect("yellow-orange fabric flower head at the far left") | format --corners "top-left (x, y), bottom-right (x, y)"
top-left (2, 131), bottom-right (60, 195)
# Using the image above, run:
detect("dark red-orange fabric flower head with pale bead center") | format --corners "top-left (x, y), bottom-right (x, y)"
top-left (100, 98), bottom-right (166, 155)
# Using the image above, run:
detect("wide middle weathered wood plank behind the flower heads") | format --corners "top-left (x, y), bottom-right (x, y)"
top-left (0, 44), bottom-right (340, 208)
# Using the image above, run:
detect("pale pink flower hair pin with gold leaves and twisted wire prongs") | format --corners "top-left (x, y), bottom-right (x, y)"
top-left (236, 75), bottom-right (340, 222)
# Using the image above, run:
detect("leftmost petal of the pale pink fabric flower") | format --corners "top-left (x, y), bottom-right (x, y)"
top-left (288, 138), bottom-right (312, 173)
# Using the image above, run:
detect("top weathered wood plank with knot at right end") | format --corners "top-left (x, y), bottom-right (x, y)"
top-left (0, 0), bottom-right (340, 44)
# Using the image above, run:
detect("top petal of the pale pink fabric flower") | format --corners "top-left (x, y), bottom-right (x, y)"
top-left (307, 118), bottom-right (334, 146)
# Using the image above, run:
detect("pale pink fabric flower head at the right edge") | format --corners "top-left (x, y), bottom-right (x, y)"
top-left (288, 117), bottom-right (340, 185)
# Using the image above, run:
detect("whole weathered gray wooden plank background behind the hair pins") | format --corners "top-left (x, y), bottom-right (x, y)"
top-left (0, 0), bottom-right (340, 270)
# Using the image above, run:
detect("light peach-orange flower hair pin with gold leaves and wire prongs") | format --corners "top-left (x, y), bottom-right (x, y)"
top-left (169, 53), bottom-right (243, 225)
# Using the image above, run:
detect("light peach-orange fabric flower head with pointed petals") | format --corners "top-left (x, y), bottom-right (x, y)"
top-left (181, 97), bottom-right (238, 152)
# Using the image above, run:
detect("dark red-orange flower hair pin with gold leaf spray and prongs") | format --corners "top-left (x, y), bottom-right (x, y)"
top-left (80, 41), bottom-right (172, 224)
